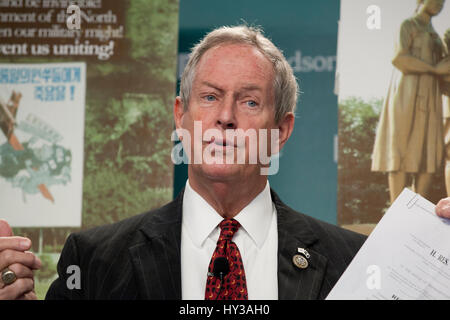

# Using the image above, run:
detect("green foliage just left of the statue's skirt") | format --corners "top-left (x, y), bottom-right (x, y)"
top-left (338, 97), bottom-right (389, 224)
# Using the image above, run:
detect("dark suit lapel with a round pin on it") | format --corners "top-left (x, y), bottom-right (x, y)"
top-left (272, 191), bottom-right (327, 300)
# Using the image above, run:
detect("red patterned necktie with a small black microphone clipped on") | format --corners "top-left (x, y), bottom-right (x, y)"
top-left (205, 219), bottom-right (248, 300)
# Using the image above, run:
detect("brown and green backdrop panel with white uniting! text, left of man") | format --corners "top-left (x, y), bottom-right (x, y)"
top-left (0, 0), bottom-right (178, 298)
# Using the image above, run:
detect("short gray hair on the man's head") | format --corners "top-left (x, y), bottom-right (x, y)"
top-left (180, 25), bottom-right (299, 123)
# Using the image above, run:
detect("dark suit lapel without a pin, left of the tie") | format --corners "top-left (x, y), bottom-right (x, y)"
top-left (129, 191), bottom-right (184, 300)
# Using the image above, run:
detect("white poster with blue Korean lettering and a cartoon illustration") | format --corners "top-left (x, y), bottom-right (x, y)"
top-left (0, 63), bottom-right (86, 227)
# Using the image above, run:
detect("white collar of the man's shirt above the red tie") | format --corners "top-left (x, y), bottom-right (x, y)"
top-left (183, 180), bottom-right (274, 248)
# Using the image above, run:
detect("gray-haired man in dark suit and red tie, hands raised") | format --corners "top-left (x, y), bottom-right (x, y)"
top-left (0, 26), bottom-right (450, 299)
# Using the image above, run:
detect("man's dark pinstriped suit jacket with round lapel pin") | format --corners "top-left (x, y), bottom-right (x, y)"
top-left (46, 190), bottom-right (366, 299)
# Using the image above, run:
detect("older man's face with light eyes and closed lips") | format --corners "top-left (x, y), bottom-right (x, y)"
top-left (175, 44), bottom-right (284, 180)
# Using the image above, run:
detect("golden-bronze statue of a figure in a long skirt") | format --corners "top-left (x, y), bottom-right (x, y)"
top-left (372, 0), bottom-right (450, 202)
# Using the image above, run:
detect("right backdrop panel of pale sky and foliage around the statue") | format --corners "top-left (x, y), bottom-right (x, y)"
top-left (337, 0), bottom-right (450, 233)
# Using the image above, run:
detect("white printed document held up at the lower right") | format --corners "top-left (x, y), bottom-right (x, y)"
top-left (327, 189), bottom-right (450, 300)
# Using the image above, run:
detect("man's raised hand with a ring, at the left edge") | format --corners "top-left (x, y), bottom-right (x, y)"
top-left (0, 220), bottom-right (41, 300)
